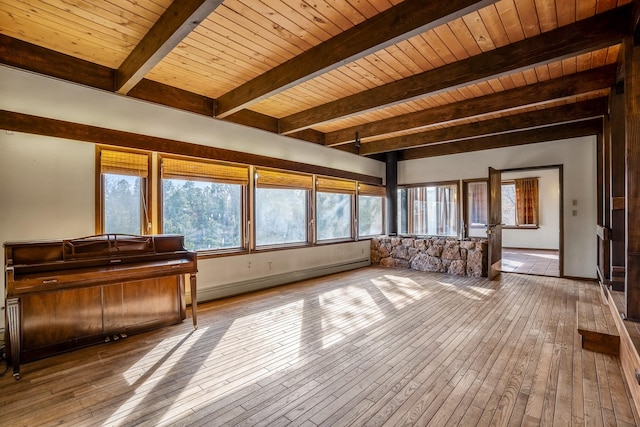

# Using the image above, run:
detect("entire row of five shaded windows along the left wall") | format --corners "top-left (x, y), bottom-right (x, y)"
top-left (96, 146), bottom-right (385, 255)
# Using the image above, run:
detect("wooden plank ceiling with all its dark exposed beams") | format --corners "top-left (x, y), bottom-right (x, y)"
top-left (0, 0), bottom-right (633, 159)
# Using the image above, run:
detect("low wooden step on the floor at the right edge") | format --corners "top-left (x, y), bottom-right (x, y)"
top-left (576, 301), bottom-right (620, 356)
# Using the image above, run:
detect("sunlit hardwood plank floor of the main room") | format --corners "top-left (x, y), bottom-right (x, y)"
top-left (0, 267), bottom-right (638, 426)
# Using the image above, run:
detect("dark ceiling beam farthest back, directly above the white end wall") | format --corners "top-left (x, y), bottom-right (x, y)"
top-left (398, 118), bottom-right (603, 160)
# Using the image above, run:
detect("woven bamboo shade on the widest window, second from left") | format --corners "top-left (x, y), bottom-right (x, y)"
top-left (162, 157), bottom-right (249, 185)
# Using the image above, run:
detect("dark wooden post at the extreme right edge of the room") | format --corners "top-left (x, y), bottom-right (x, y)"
top-left (623, 33), bottom-right (640, 321)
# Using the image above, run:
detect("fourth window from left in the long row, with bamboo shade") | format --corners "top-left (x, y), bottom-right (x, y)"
top-left (316, 177), bottom-right (356, 241)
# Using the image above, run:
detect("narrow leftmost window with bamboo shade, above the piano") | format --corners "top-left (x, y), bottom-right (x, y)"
top-left (97, 149), bottom-right (151, 234)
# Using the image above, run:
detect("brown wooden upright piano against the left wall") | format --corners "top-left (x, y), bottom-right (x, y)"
top-left (4, 234), bottom-right (197, 379)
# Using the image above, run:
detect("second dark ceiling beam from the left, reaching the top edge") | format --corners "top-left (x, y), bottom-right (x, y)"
top-left (216, 0), bottom-right (497, 118)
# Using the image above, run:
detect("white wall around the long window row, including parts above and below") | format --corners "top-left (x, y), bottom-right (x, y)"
top-left (0, 66), bottom-right (384, 329)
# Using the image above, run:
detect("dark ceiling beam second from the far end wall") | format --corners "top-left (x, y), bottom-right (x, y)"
top-left (360, 97), bottom-right (608, 155)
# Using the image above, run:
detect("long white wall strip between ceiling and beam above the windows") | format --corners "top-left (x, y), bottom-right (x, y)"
top-left (0, 66), bottom-right (385, 177)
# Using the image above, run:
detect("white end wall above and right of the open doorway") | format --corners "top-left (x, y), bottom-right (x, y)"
top-left (398, 137), bottom-right (597, 278)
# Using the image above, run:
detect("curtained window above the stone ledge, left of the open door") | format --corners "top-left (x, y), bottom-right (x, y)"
top-left (398, 183), bottom-right (458, 236)
